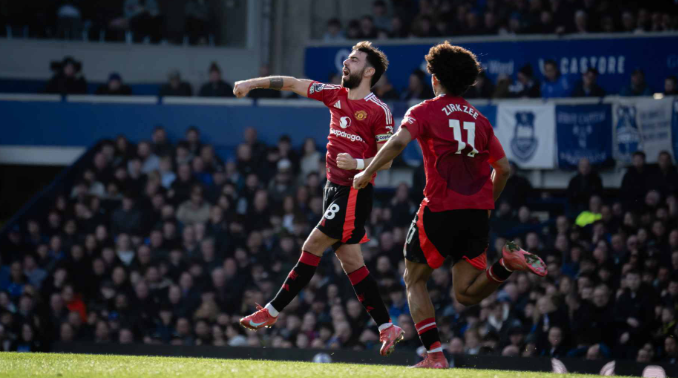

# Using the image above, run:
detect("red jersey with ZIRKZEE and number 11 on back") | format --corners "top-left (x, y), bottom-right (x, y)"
top-left (401, 95), bottom-right (504, 212)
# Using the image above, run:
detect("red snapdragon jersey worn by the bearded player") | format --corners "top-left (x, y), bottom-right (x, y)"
top-left (308, 82), bottom-right (393, 186)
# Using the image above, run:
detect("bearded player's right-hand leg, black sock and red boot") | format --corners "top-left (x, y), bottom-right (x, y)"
top-left (335, 244), bottom-right (403, 356)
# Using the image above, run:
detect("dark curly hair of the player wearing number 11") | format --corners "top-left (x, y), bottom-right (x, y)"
top-left (426, 41), bottom-right (482, 96)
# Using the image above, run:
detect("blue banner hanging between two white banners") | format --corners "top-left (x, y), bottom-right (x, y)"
top-left (556, 104), bottom-right (614, 169)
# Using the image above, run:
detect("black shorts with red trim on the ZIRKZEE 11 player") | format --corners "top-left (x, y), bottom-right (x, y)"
top-left (403, 199), bottom-right (490, 270)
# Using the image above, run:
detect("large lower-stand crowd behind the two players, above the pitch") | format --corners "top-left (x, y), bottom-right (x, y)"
top-left (0, 127), bottom-right (678, 363)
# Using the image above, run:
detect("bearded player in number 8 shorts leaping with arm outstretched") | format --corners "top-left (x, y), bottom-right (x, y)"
top-left (233, 42), bottom-right (403, 355)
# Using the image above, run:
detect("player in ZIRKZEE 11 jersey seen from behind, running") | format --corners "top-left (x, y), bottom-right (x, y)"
top-left (353, 41), bottom-right (546, 368)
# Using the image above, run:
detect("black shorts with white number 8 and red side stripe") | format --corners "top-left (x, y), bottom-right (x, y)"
top-left (316, 181), bottom-right (374, 250)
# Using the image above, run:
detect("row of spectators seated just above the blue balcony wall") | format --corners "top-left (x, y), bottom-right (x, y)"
top-left (44, 57), bottom-right (678, 101)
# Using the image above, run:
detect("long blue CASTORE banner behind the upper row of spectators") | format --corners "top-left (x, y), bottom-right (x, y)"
top-left (305, 35), bottom-right (678, 94)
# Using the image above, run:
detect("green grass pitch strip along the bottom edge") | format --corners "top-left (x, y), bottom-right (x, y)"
top-left (0, 353), bottom-right (586, 378)
